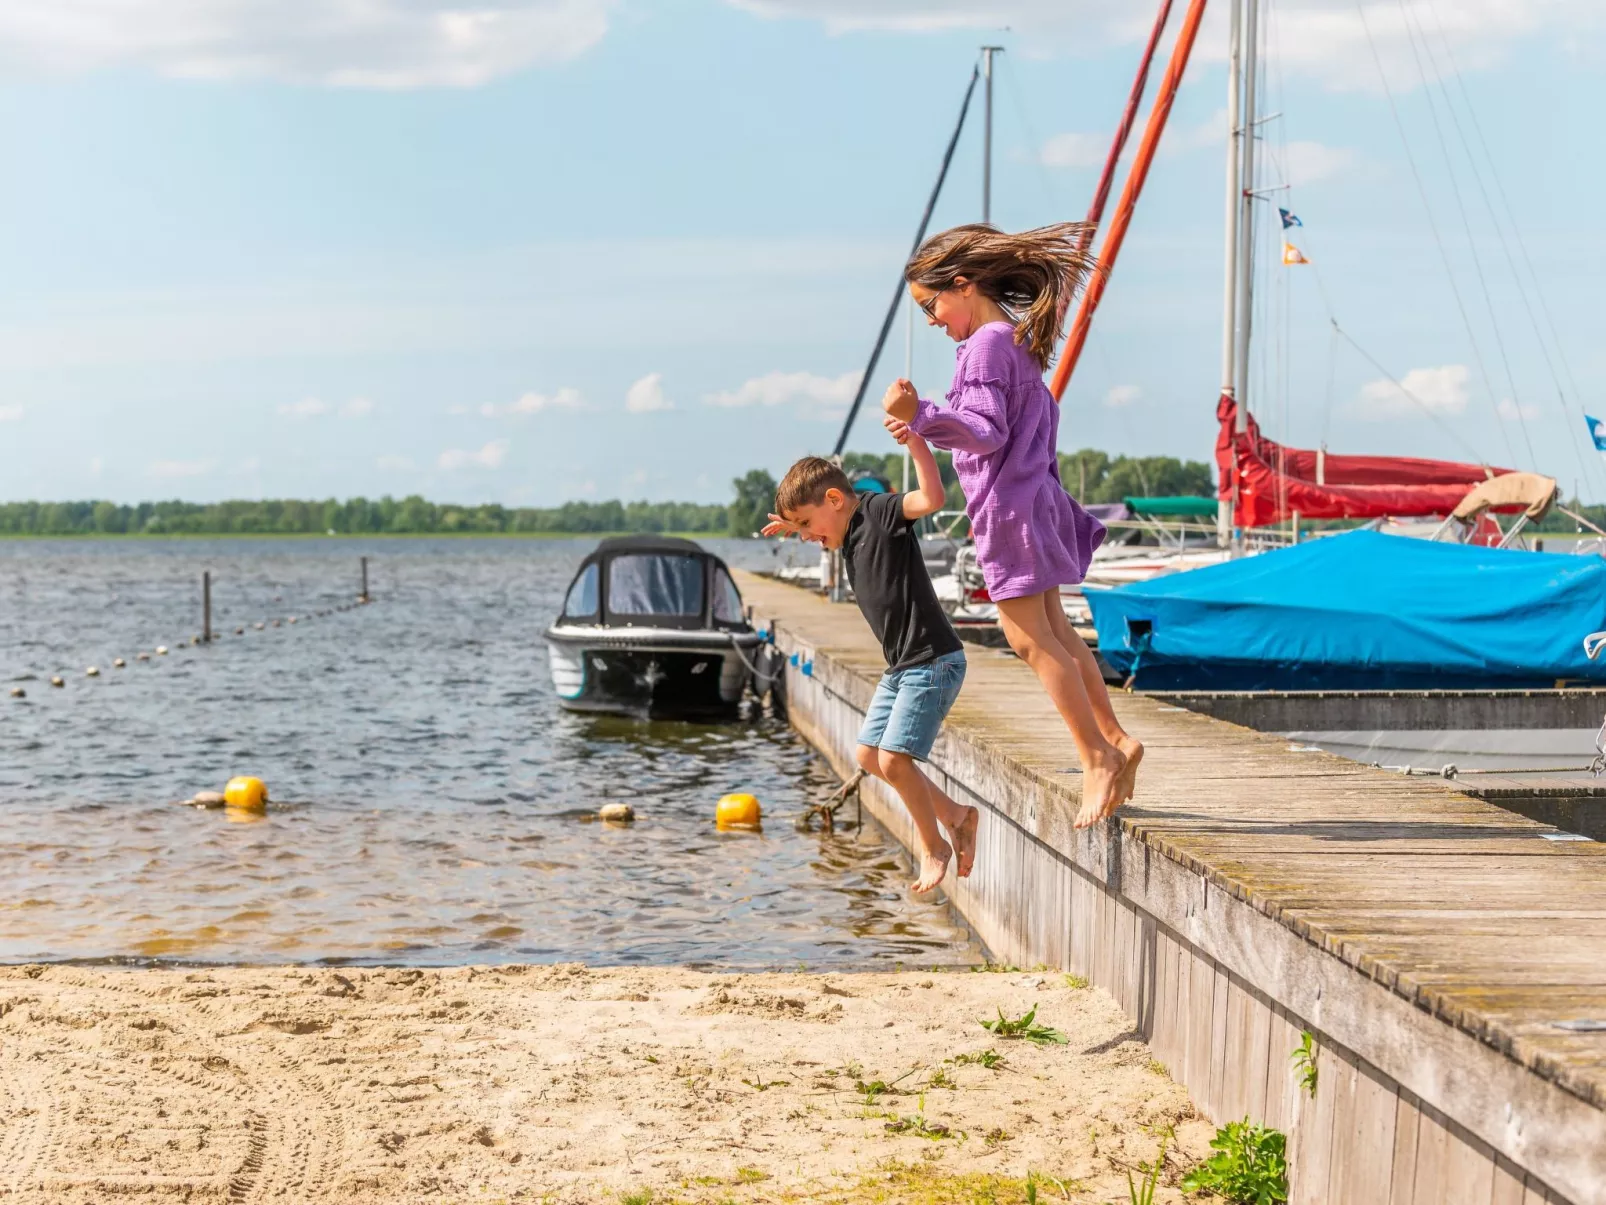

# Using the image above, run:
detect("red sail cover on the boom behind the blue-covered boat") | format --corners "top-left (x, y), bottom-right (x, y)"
top-left (1216, 394), bottom-right (1510, 527)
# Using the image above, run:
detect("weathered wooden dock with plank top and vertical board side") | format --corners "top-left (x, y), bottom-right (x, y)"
top-left (740, 574), bottom-right (1606, 1205)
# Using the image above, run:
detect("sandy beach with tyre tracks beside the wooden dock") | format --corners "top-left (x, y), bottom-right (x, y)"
top-left (0, 966), bottom-right (1213, 1205)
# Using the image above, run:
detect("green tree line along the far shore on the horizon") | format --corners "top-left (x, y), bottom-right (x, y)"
top-left (0, 448), bottom-right (1214, 535)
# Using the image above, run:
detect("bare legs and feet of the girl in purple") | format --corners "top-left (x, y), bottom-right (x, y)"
top-left (997, 586), bottom-right (1126, 829)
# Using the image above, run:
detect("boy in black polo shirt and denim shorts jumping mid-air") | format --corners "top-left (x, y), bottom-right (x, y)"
top-left (764, 432), bottom-right (980, 892)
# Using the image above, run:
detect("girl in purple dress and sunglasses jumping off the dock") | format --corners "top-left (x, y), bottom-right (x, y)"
top-left (882, 223), bottom-right (1143, 827)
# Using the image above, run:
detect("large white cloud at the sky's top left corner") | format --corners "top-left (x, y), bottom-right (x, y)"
top-left (0, 0), bottom-right (615, 88)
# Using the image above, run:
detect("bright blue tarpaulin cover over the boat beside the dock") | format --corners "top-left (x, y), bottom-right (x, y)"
top-left (1086, 532), bottom-right (1606, 691)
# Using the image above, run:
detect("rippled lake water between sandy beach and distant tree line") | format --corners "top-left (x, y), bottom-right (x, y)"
top-left (0, 540), bottom-right (981, 967)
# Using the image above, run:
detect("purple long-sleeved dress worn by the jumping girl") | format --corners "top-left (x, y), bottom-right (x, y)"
top-left (909, 323), bottom-right (1105, 599)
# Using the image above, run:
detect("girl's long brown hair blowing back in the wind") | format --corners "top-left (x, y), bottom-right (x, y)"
top-left (904, 222), bottom-right (1095, 371)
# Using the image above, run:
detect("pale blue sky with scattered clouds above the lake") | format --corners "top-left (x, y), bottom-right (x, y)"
top-left (0, 0), bottom-right (1606, 506)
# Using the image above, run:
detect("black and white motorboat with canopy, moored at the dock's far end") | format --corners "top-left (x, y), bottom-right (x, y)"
top-left (546, 535), bottom-right (761, 718)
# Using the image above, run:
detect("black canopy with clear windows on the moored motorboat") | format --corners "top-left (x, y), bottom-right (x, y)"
top-left (559, 535), bottom-right (747, 631)
